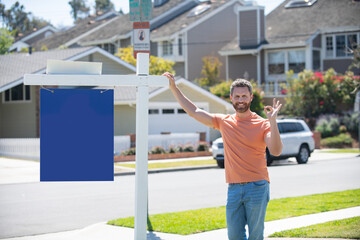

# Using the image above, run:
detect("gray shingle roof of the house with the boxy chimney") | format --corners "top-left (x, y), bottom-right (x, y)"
top-left (222, 0), bottom-right (360, 51)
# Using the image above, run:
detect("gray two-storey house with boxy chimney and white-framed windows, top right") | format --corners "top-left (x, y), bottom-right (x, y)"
top-left (219, 0), bottom-right (360, 98)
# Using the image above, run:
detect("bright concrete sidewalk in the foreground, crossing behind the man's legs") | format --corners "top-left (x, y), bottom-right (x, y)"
top-left (4, 207), bottom-right (360, 240)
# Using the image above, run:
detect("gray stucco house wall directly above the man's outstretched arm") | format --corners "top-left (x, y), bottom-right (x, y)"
top-left (186, 2), bottom-right (237, 81)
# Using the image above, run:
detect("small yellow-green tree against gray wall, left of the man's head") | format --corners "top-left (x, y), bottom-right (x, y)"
top-left (197, 56), bottom-right (222, 87)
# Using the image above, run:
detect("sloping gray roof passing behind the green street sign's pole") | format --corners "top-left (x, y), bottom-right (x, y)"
top-left (79, 0), bottom-right (183, 44)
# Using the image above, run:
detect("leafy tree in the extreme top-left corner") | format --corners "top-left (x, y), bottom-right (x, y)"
top-left (0, 2), bottom-right (49, 37)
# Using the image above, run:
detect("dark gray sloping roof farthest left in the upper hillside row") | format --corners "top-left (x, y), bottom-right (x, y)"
top-left (32, 12), bottom-right (118, 50)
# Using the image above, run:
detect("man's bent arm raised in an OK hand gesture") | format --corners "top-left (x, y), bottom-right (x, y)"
top-left (264, 98), bottom-right (283, 156)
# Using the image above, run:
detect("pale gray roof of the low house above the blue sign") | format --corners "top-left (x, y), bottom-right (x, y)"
top-left (0, 47), bottom-right (94, 90)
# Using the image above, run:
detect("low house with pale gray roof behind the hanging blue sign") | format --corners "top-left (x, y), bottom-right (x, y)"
top-left (0, 47), bottom-right (136, 138)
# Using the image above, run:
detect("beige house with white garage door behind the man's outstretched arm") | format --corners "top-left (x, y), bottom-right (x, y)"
top-left (114, 78), bottom-right (234, 142)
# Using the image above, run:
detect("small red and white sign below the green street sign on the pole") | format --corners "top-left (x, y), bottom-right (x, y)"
top-left (133, 22), bottom-right (150, 58)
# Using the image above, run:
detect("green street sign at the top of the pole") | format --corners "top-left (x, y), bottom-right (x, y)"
top-left (129, 0), bottom-right (152, 22)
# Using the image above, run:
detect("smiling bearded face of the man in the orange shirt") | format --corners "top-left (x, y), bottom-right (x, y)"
top-left (230, 87), bottom-right (253, 113)
